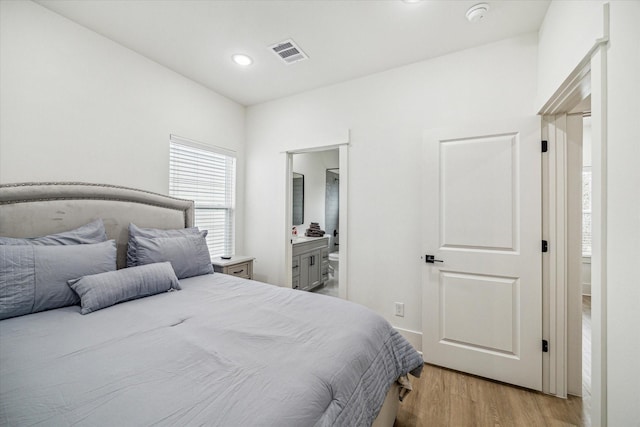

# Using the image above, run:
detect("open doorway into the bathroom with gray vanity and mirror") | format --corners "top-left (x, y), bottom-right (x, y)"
top-left (285, 143), bottom-right (348, 299)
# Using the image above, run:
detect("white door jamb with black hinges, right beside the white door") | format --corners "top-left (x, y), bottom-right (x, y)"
top-left (542, 114), bottom-right (582, 398)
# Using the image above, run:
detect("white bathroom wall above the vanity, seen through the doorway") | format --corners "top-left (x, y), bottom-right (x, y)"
top-left (293, 149), bottom-right (340, 236)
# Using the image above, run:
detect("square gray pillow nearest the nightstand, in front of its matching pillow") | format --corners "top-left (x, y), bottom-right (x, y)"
top-left (136, 230), bottom-right (213, 279)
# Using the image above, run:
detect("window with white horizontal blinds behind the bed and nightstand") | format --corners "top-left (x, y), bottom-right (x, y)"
top-left (169, 135), bottom-right (236, 258)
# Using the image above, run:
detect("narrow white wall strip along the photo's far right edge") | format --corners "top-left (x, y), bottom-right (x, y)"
top-left (594, 1), bottom-right (640, 427)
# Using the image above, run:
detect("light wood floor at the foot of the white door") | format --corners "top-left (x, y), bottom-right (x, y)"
top-left (394, 297), bottom-right (591, 427)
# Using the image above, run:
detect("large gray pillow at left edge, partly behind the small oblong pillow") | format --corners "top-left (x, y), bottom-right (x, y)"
top-left (0, 240), bottom-right (116, 319)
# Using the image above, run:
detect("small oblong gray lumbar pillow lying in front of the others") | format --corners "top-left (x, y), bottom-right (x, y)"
top-left (67, 262), bottom-right (180, 314)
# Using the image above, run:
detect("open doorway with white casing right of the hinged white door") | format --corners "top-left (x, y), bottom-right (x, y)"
top-left (539, 38), bottom-right (607, 425)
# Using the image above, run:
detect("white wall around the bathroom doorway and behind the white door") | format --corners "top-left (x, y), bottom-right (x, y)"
top-left (245, 34), bottom-right (537, 331)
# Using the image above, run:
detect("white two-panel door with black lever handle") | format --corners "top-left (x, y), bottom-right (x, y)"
top-left (422, 117), bottom-right (542, 390)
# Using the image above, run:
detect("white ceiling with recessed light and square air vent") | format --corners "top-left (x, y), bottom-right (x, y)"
top-left (36, 0), bottom-right (549, 105)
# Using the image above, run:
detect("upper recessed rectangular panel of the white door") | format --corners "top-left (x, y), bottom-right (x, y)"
top-left (440, 134), bottom-right (518, 250)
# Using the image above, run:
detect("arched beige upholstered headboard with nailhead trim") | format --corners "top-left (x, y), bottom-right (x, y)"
top-left (0, 182), bottom-right (194, 268)
